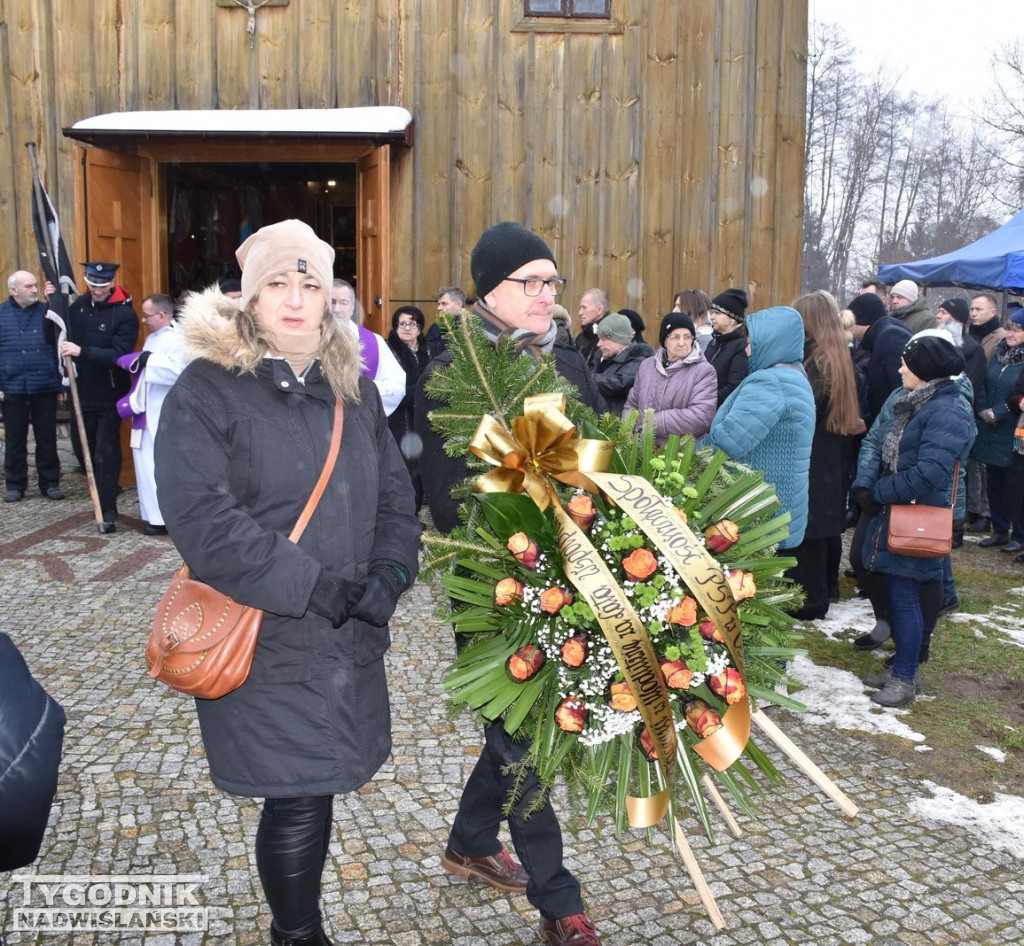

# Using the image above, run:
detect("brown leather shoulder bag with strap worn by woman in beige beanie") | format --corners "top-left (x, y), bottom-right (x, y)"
top-left (145, 400), bottom-right (344, 699)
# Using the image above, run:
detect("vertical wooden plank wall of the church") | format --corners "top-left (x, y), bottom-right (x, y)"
top-left (0, 0), bottom-right (807, 329)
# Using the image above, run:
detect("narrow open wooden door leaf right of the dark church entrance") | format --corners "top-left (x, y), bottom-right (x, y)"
top-left (355, 144), bottom-right (391, 337)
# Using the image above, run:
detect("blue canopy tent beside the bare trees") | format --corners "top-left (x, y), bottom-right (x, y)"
top-left (879, 210), bottom-right (1024, 295)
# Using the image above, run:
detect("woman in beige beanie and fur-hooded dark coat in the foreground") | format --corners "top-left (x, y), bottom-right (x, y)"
top-left (156, 220), bottom-right (420, 946)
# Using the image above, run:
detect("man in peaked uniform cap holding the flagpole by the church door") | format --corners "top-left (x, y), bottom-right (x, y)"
top-left (60, 262), bottom-right (138, 533)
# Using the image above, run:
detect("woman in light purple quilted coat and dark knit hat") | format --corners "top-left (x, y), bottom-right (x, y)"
top-left (623, 312), bottom-right (718, 446)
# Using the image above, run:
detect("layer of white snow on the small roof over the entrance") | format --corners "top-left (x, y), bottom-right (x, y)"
top-left (65, 105), bottom-right (413, 139)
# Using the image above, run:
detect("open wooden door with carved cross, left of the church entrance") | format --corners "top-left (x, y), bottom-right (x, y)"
top-left (75, 147), bottom-right (153, 485)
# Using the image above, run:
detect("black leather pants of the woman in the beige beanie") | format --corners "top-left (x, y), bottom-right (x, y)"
top-left (256, 796), bottom-right (334, 939)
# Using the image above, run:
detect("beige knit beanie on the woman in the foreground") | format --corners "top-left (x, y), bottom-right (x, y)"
top-left (234, 220), bottom-right (334, 308)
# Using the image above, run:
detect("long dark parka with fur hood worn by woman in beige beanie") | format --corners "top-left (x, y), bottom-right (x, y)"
top-left (156, 292), bottom-right (420, 798)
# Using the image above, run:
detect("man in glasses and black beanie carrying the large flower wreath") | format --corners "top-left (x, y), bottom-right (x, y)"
top-left (414, 222), bottom-right (602, 946)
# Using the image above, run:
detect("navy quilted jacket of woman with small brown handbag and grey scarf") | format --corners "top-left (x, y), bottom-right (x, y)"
top-left (853, 381), bottom-right (971, 582)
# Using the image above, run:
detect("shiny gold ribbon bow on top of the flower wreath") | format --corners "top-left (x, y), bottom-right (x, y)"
top-left (469, 394), bottom-right (614, 510)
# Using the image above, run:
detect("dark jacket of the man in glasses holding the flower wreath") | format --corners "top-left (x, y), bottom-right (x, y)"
top-left (414, 317), bottom-right (606, 532)
